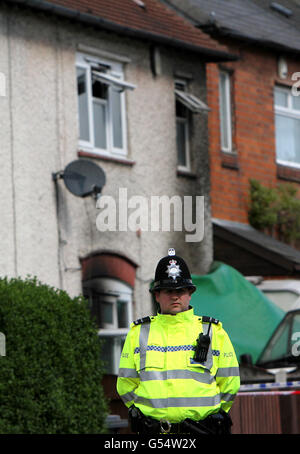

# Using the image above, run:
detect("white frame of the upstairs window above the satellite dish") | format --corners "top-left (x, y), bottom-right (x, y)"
top-left (76, 53), bottom-right (135, 157)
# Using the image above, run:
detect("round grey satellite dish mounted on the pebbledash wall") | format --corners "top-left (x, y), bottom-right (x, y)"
top-left (53, 159), bottom-right (106, 197)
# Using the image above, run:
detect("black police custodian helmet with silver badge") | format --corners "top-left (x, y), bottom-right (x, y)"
top-left (150, 248), bottom-right (196, 293)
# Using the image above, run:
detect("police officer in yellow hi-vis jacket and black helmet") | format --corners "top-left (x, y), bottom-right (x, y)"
top-left (117, 249), bottom-right (240, 434)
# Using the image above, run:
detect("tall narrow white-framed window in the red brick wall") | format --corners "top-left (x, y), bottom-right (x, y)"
top-left (219, 70), bottom-right (233, 153)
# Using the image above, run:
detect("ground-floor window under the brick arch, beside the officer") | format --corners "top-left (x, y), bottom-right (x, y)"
top-left (83, 278), bottom-right (132, 375)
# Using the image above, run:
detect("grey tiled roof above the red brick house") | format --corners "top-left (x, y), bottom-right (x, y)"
top-left (168, 0), bottom-right (300, 53)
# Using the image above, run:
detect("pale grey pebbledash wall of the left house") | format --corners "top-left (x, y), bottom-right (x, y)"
top-left (0, 7), bottom-right (212, 318)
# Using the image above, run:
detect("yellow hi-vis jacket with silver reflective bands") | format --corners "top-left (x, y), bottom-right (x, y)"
top-left (117, 308), bottom-right (240, 423)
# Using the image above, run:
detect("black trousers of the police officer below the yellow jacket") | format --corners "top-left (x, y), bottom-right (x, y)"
top-left (129, 405), bottom-right (232, 435)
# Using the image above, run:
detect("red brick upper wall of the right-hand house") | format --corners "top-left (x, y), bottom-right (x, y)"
top-left (207, 41), bottom-right (300, 223)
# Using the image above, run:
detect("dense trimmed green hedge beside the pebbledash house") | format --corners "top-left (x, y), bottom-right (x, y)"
top-left (0, 277), bottom-right (107, 434)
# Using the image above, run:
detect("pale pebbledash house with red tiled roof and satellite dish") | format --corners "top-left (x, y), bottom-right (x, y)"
top-left (0, 0), bottom-right (234, 422)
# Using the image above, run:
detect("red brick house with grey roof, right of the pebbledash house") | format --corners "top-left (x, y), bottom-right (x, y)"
top-left (168, 0), bottom-right (300, 276)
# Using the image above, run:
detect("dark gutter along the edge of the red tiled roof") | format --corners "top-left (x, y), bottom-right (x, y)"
top-left (2, 0), bottom-right (239, 62)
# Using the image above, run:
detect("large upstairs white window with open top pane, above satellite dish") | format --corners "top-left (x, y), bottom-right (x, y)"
top-left (76, 54), bottom-right (135, 155)
